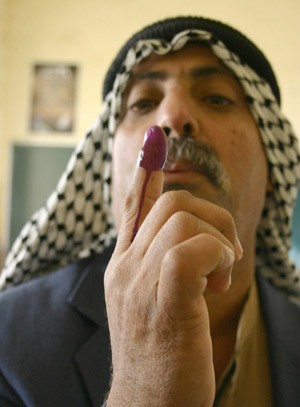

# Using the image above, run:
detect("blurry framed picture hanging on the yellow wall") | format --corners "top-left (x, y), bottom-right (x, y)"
top-left (30, 64), bottom-right (78, 132)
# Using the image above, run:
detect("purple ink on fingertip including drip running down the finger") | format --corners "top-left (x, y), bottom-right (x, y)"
top-left (131, 126), bottom-right (168, 242)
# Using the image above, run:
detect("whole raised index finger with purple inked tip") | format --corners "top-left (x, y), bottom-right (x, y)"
top-left (116, 126), bottom-right (167, 251)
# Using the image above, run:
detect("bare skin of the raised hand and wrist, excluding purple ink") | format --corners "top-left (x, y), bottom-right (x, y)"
top-left (105, 164), bottom-right (240, 407)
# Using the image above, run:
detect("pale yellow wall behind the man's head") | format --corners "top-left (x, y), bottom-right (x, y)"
top-left (0, 0), bottom-right (300, 250)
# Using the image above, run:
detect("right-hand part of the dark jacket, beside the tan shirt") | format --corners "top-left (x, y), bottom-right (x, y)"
top-left (257, 275), bottom-right (300, 407)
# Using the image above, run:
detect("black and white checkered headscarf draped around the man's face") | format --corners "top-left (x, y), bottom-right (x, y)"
top-left (0, 30), bottom-right (300, 303)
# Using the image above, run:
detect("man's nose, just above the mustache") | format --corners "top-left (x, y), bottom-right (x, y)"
top-left (158, 89), bottom-right (199, 138)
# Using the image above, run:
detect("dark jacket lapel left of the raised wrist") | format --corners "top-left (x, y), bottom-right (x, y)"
top-left (68, 245), bottom-right (112, 407)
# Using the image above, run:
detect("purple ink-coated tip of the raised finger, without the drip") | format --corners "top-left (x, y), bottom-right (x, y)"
top-left (138, 126), bottom-right (168, 172)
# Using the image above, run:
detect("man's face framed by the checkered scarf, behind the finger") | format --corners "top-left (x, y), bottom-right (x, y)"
top-left (112, 44), bottom-right (267, 245)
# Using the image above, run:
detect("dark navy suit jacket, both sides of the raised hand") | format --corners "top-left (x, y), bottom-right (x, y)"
top-left (0, 244), bottom-right (300, 407)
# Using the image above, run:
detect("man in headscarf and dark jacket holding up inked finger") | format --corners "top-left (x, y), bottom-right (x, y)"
top-left (0, 18), bottom-right (300, 406)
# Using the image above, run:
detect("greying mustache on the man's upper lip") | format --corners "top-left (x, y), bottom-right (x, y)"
top-left (165, 137), bottom-right (225, 187)
